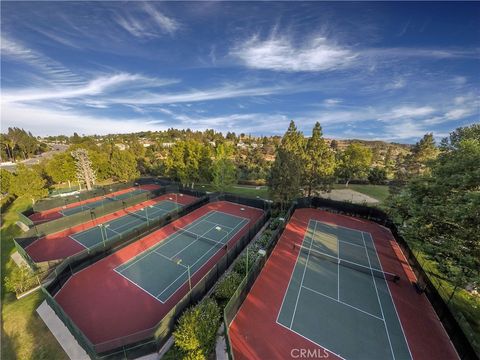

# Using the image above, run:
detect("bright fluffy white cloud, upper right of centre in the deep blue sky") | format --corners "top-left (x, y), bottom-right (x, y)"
top-left (230, 36), bottom-right (356, 72)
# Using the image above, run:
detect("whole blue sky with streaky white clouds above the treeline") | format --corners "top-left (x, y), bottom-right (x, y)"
top-left (1, 1), bottom-right (480, 143)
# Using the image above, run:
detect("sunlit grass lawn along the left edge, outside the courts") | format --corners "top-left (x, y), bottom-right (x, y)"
top-left (1, 199), bottom-right (68, 360)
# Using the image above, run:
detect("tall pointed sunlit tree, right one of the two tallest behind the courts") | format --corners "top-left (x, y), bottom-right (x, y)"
top-left (304, 122), bottom-right (335, 196)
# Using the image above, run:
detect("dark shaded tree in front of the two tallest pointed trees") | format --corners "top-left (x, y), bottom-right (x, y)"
top-left (268, 147), bottom-right (303, 210)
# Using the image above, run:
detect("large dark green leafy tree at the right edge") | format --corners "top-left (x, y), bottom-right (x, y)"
top-left (390, 124), bottom-right (480, 300)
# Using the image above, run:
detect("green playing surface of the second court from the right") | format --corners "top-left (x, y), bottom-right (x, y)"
top-left (115, 211), bottom-right (249, 303)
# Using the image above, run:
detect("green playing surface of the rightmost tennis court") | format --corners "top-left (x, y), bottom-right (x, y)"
top-left (277, 220), bottom-right (412, 360)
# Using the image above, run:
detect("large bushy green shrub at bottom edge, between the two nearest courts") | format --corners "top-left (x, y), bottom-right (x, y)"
top-left (173, 298), bottom-right (220, 360)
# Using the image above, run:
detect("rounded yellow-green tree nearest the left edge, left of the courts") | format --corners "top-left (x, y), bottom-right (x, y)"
top-left (11, 164), bottom-right (48, 203)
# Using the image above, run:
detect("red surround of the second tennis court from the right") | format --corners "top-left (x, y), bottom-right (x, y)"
top-left (55, 201), bottom-right (263, 350)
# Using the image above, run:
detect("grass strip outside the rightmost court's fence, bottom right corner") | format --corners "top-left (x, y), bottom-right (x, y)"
top-left (410, 243), bottom-right (480, 355)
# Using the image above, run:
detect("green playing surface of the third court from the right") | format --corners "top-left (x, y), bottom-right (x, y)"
top-left (70, 200), bottom-right (182, 248)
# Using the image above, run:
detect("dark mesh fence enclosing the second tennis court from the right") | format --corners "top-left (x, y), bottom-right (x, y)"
top-left (43, 193), bottom-right (271, 360)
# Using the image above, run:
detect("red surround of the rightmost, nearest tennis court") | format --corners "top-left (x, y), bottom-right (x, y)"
top-left (229, 209), bottom-right (458, 360)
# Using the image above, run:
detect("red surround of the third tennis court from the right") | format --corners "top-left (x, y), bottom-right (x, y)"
top-left (25, 193), bottom-right (197, 262)
